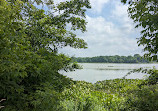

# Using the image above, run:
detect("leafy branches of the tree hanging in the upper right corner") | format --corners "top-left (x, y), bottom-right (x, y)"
top-left (121, 0), bottom-right (158, 61)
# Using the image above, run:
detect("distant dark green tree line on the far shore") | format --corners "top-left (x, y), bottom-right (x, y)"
top-left (73, 54), bottom-right (149, 63)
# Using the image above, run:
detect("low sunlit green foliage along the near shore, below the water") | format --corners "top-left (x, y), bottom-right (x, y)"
top-left (55, 79), bottom-right (158, 111)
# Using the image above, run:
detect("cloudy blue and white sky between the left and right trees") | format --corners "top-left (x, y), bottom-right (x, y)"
top-left (37, 0), bottom-right (143, 57)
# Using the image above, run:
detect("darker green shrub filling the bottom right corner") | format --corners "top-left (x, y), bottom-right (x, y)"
top-left (123, 85), bottom-right (158, 111)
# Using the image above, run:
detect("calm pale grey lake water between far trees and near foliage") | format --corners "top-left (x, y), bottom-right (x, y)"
top-left (62, 63), bottom-right (158, 83)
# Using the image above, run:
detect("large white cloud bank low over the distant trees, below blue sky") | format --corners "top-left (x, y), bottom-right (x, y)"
top-left (59, 16), bottom-right (141, 56)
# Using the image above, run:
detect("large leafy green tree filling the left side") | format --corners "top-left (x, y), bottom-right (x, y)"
top-left (0, 0), bottom-right (90, 111)
